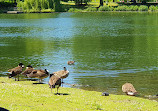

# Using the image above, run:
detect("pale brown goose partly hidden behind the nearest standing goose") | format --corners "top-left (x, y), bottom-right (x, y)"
top-left (53, 67), bottom-right (69, 86)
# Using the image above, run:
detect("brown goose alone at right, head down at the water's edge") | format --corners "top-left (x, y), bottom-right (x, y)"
top-left (122, 83), bottom-right (137, 96)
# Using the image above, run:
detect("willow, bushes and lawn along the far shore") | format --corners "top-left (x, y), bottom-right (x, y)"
top-left (0, 0), bottom-right (158, 12)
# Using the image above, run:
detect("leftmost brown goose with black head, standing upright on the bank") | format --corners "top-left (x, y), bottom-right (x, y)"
top-left (8, 63), bottom-right (24, 81)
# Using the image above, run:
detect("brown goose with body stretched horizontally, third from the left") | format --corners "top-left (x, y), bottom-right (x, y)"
top-left (26, 69), bottom-right (49, 82)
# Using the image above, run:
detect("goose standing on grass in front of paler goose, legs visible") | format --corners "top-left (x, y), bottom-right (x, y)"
top-left (48, 74), bottom-right (61, 94)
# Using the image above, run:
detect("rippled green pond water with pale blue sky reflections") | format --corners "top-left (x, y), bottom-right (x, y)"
top-left (0, 12), bottom-right (158, 100)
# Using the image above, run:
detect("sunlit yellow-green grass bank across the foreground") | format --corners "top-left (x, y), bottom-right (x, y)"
top-left (0, 77), bottom-right (158, 111)
